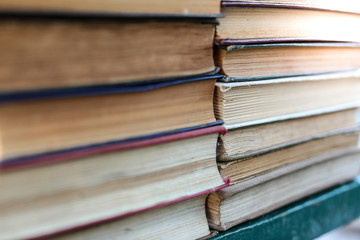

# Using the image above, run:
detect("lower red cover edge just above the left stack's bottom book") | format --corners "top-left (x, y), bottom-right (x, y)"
top-left (27, 178), bottom-right (230, 240)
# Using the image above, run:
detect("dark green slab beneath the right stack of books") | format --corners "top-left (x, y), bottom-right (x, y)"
top-left (212, 176), bottom-right (360, 240)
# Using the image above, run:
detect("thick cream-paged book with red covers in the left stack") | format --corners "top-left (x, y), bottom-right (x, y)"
top-left (0, 126), bottom-right (229, 239)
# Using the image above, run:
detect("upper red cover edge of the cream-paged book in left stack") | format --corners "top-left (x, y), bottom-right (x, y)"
top-left (0, 125), bottom-right (227, 173)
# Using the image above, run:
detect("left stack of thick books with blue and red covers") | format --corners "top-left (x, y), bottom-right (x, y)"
top-left (0, 0), bottom-right (229, 239)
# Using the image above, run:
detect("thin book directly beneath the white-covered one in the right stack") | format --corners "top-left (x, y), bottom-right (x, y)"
top-left (217, 108), bottom-right (358, 161)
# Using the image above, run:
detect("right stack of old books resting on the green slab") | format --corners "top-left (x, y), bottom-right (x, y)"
top-left (207, 1), bottom-right (360, 231)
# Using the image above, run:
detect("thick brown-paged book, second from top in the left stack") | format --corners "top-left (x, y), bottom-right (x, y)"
top-left (0, 16), bottom-right (216, 92)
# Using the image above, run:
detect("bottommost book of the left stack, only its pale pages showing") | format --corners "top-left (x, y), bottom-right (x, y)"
top-left (52, 196), bottom-right (215, 240)
